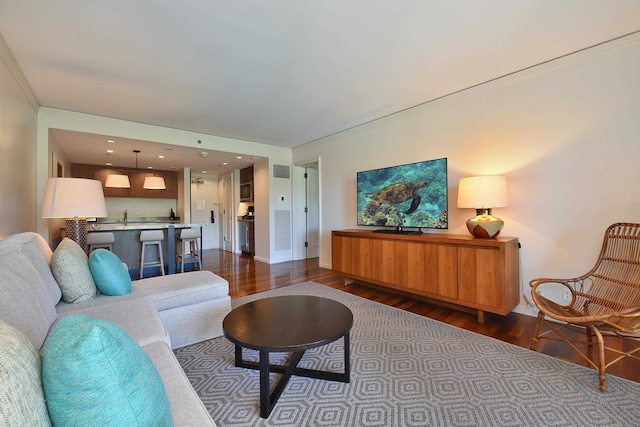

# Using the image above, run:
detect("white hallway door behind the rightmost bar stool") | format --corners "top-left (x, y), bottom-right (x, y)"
top-left (191, 177), bottom-right (220, 249)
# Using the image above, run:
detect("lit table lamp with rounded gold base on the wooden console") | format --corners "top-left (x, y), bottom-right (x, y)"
top-left (458, 176), bottom-right (508, 239)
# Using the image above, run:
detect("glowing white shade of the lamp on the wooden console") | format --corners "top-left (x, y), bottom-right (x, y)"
top-left (458, 176), bottom-right (508, 209)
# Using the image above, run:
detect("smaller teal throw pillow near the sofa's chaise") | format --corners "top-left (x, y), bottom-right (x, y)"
top-left (89, 249), bottom-right (131, 296)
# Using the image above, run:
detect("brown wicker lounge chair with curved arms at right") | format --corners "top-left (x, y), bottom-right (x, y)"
top-left (529, 223), bottom-right (640, 392)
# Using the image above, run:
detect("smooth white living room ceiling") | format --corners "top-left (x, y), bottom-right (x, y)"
top-left (0, 0), bottom-right (640, 169)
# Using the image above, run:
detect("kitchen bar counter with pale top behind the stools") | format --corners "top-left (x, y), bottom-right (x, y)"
top-left (87, 222), bottom-right (202, 278)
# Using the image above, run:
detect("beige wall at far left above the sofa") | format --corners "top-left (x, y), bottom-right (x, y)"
top-left (0, 37), bottom-right (38, 239)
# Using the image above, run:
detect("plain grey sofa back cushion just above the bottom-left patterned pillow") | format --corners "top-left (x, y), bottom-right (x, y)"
top-left (0, 251), bottom-right (57, 349)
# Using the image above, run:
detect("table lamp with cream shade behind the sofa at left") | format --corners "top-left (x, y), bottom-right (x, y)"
top-left (42, 178), bottom-right (107, 253)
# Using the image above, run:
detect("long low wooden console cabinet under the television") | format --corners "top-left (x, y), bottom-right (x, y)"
top-left (331, 230), bottom-right (520, 322)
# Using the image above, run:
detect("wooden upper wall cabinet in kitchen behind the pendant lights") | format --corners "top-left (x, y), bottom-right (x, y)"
top-left (71, 163), bottom-right (178, 199)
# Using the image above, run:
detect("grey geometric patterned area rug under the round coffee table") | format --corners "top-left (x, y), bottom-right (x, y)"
top-left (175, 282), bottom-right (640, 427)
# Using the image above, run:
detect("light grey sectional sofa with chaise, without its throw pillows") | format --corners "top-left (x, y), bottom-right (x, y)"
top-left (0, 232), bottom-right (231, 426)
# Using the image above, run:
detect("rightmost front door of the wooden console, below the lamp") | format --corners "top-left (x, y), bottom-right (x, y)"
top-left (458, 246), bottom-right (505, 308)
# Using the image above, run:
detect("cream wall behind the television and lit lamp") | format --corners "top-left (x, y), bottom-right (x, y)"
top-left (293, 34), bottom-right (640, 318)
